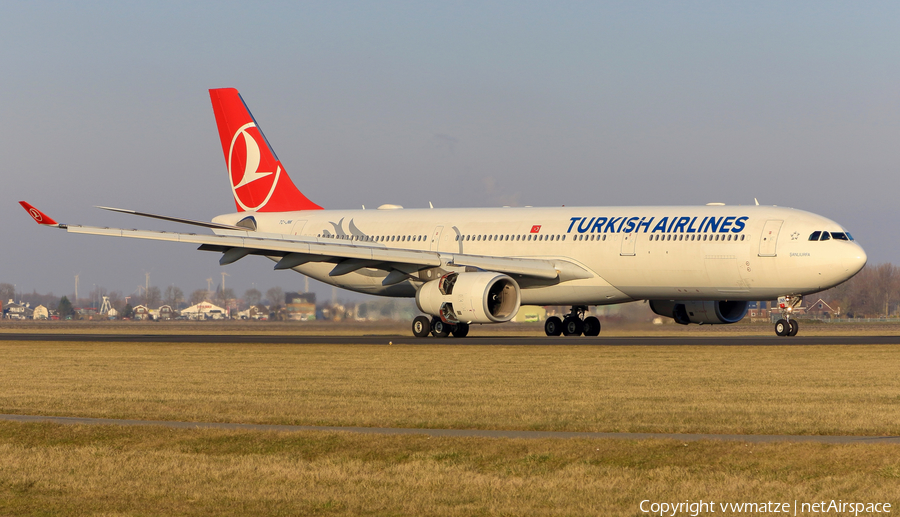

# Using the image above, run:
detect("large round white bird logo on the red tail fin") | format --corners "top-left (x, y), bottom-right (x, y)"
top-left (228, 122), bottom-right (281, 211)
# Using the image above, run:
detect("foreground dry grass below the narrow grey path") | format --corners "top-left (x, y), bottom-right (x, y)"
top-left (0, 422), bottom-right (900, 516)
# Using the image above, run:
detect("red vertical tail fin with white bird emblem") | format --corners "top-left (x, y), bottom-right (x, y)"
top-left (209, 88), bottom-right (322, 212)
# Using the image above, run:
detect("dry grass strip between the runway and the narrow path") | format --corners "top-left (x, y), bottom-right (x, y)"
top-left (0, 342), bottom-right (900, 435)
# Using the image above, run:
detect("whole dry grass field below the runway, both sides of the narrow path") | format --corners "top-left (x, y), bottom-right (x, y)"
top-left (0, 332), bottom-right (900, 515)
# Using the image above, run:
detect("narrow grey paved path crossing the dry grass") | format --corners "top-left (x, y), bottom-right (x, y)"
top-left (0, 415), bottom-right (900, 444)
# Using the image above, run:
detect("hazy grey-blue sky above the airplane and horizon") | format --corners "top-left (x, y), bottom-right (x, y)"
top-left (0, 1), bottom-right (900, 299)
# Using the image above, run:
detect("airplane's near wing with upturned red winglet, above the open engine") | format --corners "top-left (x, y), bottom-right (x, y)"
top-left (21, 202), bottom-right (594, 285)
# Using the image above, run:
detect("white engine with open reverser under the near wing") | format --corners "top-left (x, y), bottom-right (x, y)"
top-left (416, 272), bottom-right (522, 323)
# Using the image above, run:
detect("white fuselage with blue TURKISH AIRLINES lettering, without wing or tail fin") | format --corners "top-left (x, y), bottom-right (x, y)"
top-left (214, 205), bottom-right (866, 305)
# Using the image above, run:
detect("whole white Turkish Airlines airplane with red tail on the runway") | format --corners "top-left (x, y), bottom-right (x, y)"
top-left (20, 88), bottom-right (867, 337)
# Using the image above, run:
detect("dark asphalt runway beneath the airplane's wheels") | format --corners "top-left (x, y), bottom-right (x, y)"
top-left (0, 332), bottom-right (900, 346)
